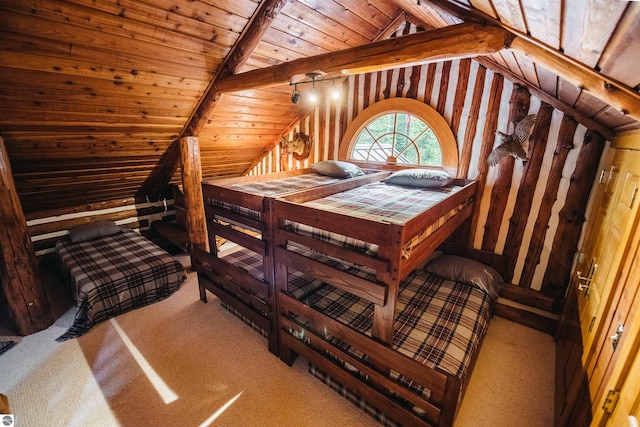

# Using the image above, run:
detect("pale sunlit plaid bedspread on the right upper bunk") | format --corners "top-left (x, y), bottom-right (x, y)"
top-left (286, 182), bottom-right (465, 259)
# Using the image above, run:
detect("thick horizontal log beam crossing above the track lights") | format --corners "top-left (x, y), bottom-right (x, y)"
top-left (217, 23), bottom-right (508, 93)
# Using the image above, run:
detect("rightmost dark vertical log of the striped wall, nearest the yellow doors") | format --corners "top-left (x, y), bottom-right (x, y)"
top-left (542, 130), bottom-right (605, 298)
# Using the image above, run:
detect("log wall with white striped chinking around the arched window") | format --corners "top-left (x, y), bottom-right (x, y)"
top-left (251, 22), bottom-right (605, 310)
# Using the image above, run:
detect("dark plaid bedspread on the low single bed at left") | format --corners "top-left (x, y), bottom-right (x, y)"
top-left (56, 230), bottom-right (187, 341)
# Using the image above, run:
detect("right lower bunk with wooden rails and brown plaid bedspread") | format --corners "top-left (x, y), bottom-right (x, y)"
top-left (278, 256), bottom-right (498, 426)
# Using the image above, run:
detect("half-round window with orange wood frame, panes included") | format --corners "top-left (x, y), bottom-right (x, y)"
top-left (340, 98), bottom-right (458, 172)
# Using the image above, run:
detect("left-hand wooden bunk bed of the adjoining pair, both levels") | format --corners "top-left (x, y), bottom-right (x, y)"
top-left (192, 168), bottom-right (389, 355)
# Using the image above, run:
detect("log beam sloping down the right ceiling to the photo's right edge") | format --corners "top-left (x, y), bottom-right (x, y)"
top-left (420, 0), bottom-right (640, 126)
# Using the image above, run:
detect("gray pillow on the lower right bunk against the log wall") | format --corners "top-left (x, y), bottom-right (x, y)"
top-left (424, 255), bottom-right (504, 301)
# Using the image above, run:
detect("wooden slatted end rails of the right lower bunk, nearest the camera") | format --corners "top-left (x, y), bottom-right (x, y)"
top-left (278, 293), bottom-right (462, 426)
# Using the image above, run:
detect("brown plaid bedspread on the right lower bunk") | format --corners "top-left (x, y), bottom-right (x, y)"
top-left (305, 271), bottom-right (491, 397)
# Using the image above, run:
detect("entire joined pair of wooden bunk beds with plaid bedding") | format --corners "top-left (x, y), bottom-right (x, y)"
top-left (194, 162), bottom-right (499, 425)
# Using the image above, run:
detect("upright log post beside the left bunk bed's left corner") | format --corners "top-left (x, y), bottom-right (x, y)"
top-left (180, 136), bottom-right (209, 258)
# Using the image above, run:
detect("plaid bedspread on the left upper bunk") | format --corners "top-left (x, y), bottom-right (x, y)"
top-left (213, 172), bottom-right (343, 219)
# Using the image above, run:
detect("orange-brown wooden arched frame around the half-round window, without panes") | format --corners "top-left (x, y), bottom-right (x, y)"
top-left (338, 98), bottom-right (458, 174)
